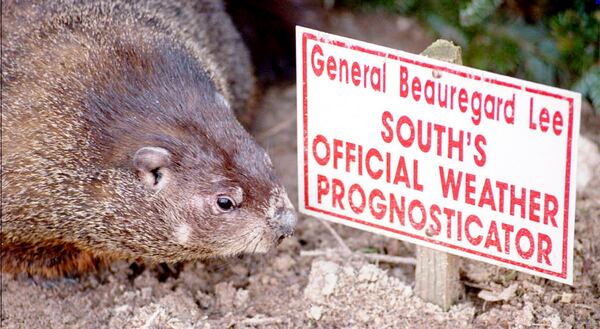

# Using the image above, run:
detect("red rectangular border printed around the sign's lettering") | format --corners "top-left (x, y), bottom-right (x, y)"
top-left (302, 32), bottom-right (574, 279)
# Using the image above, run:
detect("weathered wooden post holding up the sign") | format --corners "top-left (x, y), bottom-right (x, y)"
top-left (415, 40), bottom-right (462, 311)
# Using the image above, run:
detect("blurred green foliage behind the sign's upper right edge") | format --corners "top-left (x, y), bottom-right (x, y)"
top-left (336, 0), bottom-right (600, 114)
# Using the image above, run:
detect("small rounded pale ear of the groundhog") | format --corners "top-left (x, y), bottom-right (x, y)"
top-left (133, 146), bottom-right (171, 191)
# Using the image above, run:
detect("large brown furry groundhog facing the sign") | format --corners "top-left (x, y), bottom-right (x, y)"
top-left (0, 0), bottom-right (296, 277)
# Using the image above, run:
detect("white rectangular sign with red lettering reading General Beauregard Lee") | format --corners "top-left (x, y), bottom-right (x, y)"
top-left (296, 27), bottom-right (581, 284)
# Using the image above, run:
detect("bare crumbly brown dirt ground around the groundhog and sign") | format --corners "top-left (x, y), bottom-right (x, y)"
top-left (2, 10), bottom-right (600, 329)
